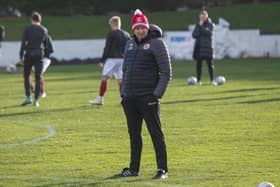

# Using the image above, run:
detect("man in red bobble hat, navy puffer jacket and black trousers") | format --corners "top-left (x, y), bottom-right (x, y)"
top-left (113, 10), bottom-right (171, 179)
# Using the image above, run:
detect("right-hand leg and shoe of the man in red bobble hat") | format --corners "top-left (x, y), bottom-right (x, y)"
top-left (138, 96), bottom-right (168, 179)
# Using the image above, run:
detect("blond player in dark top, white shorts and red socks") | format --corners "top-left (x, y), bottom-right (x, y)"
top-left (89, 16), bottom-right (130, 105)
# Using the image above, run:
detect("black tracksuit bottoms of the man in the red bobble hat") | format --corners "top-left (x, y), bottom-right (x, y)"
top-left (122, 96), bottom-right (168, 172)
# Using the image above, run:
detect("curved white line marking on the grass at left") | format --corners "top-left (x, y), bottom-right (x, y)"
top-left (0, 119), bottom-right (56, 148)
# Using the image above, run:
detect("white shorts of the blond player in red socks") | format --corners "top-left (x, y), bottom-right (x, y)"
top-left (102, 58), bottom-right (123, 80)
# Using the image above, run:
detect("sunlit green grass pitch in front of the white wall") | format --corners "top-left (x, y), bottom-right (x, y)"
top-left (0, 59), bottom-right (280, 187)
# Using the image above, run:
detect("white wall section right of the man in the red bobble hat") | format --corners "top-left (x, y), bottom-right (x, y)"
top-left (166, 27), bottom-right (280, 60)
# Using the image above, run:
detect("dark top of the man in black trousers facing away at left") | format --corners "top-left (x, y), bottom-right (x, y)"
top-left (20, 24), bottom-right (53, 59)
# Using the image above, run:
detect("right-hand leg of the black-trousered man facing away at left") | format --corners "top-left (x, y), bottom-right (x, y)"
top-left (34, 58), bottom-right (43, 106)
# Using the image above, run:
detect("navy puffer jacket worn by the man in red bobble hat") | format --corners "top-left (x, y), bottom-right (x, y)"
top-left (122, 25), bottom-right (171, 98)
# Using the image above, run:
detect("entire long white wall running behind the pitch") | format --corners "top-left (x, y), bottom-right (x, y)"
top-left (0, 27), bottom-right (280, 66)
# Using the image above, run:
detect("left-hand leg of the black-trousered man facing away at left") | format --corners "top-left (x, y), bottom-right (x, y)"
top-left (21, 60), bottom-right (32, 106)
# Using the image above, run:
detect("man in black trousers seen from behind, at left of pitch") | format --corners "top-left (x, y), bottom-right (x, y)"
top-left (20, 12), bottom-right (53, 107)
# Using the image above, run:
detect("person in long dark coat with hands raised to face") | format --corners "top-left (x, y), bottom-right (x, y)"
top-left (192, 10), bottom-right (217, 86)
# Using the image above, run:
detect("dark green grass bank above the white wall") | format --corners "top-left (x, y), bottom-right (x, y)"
top-left (0, 2), bottom-right (280, 40)
